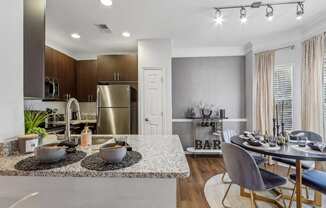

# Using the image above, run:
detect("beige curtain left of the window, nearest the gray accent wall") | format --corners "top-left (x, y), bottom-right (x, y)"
top-left (256, 51), bottom-right (275, 134)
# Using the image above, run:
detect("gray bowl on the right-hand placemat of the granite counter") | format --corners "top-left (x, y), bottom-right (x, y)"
top-left (100, 144), bottom-right (127, 163)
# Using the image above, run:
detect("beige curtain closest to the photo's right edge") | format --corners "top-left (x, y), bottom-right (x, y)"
top-left (301, 34), bottom-right (325, 135)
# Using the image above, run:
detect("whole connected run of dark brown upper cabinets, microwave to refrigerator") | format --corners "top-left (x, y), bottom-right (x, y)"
top-left (45, 51), bottom-right (138, 102)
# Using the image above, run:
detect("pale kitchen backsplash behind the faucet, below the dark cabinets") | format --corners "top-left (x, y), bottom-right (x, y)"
top-left (24, 100), bottom-right (96, 114)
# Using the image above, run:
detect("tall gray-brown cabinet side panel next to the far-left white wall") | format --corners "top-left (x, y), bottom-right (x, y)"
top-left (24, 0), bottom-right (45, 98)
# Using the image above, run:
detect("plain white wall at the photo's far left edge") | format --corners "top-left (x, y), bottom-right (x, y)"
top-left (0, 0), bottom-right (24, 142)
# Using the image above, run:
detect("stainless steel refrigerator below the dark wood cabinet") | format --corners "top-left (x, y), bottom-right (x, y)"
top-left (97, 85), bottom-right (137, 134)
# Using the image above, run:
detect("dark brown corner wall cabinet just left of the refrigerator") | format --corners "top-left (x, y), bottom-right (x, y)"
top-left (76, 60), bottom-right (97, 102)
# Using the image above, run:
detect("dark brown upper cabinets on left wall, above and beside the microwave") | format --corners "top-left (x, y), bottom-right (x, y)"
top-left (45, 47), bottom-right (76, 99)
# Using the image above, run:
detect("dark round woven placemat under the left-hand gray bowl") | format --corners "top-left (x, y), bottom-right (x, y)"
top-left (15, 151), bottom-right (87, 171)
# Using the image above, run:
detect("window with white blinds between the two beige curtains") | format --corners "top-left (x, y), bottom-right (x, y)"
top-left (273, 65), bottom-right (293, 130)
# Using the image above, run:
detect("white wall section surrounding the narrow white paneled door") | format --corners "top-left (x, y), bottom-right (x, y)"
top-left (138, 39), bottom-right (172, 134)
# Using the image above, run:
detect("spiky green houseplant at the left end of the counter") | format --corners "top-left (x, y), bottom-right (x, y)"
top-left (24, 110), bottom-right (48, 138)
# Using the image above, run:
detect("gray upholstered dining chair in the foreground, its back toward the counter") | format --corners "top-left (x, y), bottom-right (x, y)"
top-left (222, 143), bottom-right (286, 208)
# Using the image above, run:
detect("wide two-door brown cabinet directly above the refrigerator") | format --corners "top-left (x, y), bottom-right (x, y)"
top-left (97, 55), bottom-right (138, 81)
